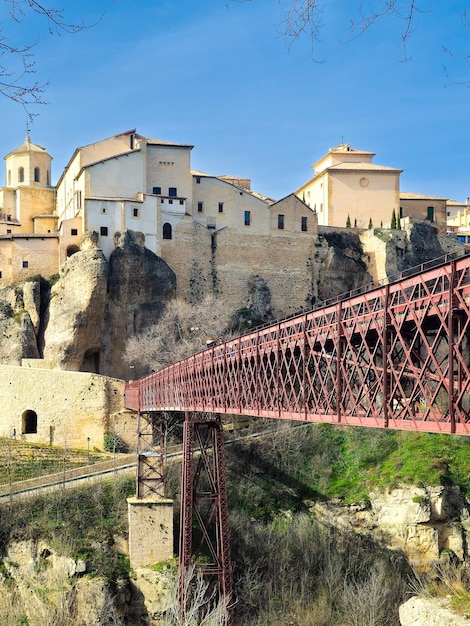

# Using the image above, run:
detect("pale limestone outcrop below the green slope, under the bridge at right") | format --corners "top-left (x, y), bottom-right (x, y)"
top-left (313, 486), bottom-right (470, 570)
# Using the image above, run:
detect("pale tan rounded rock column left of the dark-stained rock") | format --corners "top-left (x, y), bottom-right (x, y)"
top-left (44, 248), bottom-right (108, 371)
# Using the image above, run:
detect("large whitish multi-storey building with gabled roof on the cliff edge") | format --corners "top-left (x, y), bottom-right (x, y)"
top-left (57, 130), bottom-right (270, 262)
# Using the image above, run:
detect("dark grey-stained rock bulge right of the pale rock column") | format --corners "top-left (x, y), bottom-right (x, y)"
top-left (100, 231), bottom-right (176, 378)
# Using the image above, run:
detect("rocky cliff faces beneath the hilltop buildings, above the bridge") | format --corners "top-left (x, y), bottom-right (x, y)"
top-left (0, 224), bottom-right (457, 378)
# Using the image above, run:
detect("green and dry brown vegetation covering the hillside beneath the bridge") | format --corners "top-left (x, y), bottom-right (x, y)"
top-left (0, 421), bottom-right (470, 626)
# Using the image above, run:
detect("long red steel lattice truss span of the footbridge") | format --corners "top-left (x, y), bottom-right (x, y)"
top-left (126, 257), bottom-right (470, 435)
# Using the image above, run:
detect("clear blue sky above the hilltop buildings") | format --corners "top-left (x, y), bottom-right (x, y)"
top-left (0, 0), bottom-right (470, 201)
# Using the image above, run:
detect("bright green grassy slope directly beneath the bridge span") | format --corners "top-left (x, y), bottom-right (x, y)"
top-left (227, 424), bottom-right (470, 521)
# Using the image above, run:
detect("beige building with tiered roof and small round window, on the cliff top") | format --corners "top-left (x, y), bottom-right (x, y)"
top-left (295, 144), bottom-right (402, 228)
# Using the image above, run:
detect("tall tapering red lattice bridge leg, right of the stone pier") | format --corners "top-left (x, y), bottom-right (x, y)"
top-left (179, 412), bottom-right (232, 626)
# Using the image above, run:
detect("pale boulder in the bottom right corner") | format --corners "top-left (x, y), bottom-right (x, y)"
top-left (399, 597), bottom-right (468, 626)
